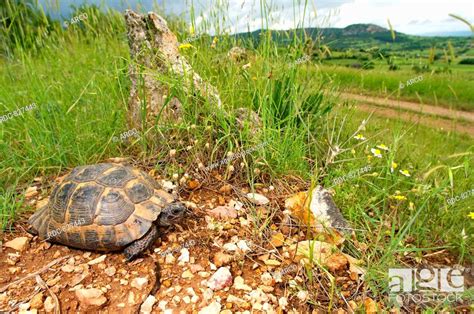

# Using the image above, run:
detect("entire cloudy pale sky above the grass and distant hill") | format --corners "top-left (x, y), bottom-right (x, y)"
top-left (39, 0), bottom-right (474, 35)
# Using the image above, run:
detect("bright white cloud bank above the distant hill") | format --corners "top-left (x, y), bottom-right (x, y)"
top-left (190, 0), bottom-right (474, 34)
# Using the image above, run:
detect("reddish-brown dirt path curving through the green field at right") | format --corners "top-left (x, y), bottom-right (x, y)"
top-left (341, 93), bottom-right (474, 137)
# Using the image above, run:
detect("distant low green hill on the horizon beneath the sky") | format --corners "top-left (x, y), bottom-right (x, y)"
top-left (234, 24), bottom-right (471, 51)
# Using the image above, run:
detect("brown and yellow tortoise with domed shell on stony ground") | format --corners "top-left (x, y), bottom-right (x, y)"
top-left (29, 163), bottom-right (187, 261)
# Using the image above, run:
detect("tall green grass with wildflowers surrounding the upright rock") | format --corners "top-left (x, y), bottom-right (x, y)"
top-left (0, 0), bottom-right (474, 312)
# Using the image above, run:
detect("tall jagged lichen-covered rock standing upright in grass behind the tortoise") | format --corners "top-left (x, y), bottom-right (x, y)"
top-left (125, 10), bottom-right (221, 129)
